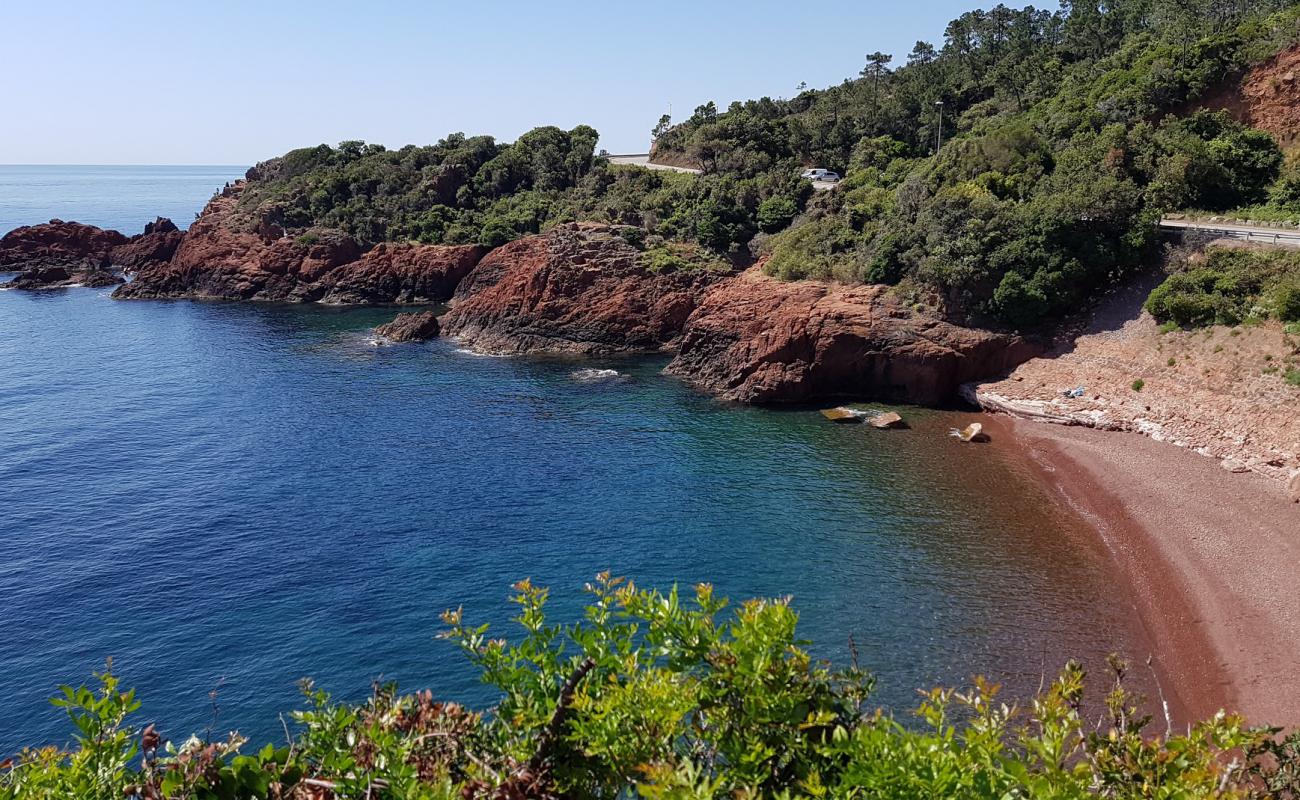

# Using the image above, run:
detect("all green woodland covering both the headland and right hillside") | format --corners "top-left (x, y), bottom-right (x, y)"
top-left (226, 0), bottom-right (1300, 327)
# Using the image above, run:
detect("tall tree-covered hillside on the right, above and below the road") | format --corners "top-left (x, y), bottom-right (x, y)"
top-left (658, 0), bottom-right (1300, 324)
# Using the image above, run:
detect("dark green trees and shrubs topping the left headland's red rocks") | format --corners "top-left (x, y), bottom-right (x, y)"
top-left (228, 126), bottom-right (811, 254)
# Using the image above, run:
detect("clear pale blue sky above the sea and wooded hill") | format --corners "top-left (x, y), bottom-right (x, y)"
top-left (0, 0), bottom-right (987, 164)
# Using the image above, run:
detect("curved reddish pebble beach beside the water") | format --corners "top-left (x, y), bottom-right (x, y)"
top-left (985, 416), bottom-right (1300, 725)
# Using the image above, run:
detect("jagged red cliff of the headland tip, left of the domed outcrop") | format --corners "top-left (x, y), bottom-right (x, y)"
top-left (113, 182), bottom-right (482, 304)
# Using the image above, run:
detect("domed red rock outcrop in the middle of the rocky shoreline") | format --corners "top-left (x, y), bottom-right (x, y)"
top-left (442, 222), bottom-right (728, 354)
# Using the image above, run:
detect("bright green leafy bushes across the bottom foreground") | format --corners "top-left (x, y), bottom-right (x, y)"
top-left (0, 575), bottom-right (1300, 800)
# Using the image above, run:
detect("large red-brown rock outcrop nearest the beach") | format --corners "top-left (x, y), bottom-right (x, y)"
top-left (668, 267), bottom-right (1036, 405)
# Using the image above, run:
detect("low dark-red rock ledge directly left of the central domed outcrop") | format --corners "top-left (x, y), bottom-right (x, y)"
top-left (320, 245), bottom-right (484, 304)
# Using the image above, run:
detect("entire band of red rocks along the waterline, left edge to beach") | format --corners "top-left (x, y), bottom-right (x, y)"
top-left (0, 188), bottom-right (1037, 405)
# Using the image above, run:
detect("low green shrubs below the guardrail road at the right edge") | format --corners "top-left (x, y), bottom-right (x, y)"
top-left (1147, 247), bottom-right (1300, 328)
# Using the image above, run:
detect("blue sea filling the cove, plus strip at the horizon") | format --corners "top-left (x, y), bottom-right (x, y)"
top-left (0, 168), bottom-right (1145, 753)
